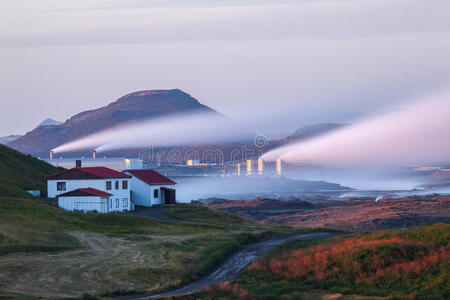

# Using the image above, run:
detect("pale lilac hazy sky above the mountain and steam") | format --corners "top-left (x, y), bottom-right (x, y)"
top-left (0, 0), bottom-right (450, 136)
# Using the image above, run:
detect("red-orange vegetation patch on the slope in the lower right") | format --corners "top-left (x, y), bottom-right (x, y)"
top-left (249, 225), bottom-right (450, 285)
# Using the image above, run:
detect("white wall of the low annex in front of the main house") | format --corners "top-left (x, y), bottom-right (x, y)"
top-left (58, 196), bottom-right (109, 213)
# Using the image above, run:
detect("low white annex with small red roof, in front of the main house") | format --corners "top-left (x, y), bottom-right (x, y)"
top-left (57, 188), bottom-right (112, 213)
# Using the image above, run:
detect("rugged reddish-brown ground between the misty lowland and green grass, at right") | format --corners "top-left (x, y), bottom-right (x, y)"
top-left (215, 196), bottom-right (450, 231)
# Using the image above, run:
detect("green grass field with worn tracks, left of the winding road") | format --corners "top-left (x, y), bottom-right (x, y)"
top-left (0, 197), bottom-right (292, 299)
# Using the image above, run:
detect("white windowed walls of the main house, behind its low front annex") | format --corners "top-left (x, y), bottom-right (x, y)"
top-left (47, 178), bottom-right (131, 212)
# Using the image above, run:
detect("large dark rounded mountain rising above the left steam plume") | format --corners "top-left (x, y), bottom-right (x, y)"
top-left (8, 89), bottom-right (219, 157)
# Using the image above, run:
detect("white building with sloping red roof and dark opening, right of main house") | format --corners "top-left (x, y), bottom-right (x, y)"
top-left (124, 170), bottom-right (176, 207)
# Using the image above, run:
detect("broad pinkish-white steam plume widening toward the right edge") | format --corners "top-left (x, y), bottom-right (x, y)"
top-left (262, 92), bottom-right (450, 167)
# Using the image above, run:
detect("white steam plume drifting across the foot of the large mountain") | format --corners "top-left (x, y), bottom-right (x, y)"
top-left (53, 112), bottom-right (252, 152)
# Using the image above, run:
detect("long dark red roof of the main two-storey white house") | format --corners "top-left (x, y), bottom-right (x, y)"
top-left (47, 167), bottom-right (131, 180)
